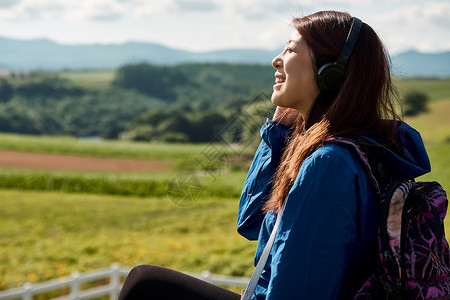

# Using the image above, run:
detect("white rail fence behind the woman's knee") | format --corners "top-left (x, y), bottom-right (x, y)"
top-left (0, 264), bottom-right (248, 300)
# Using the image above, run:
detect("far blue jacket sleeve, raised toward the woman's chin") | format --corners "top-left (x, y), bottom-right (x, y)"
top-left (237, 119), bottom-right (288, 240)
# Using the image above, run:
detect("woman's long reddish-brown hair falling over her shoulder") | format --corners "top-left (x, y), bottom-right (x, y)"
top-left (264, 11), bottom-right (400, 211)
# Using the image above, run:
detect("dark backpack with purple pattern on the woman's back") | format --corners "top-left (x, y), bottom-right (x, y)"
top-left (327, 137), bottom-right (450, 300)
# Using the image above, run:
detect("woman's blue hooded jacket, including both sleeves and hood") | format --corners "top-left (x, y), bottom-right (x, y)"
top-left (238, 120), bottom-right (430, 300)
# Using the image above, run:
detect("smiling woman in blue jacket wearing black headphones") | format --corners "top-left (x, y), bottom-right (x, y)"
top-left (120, 11), bottom-right (430, 299)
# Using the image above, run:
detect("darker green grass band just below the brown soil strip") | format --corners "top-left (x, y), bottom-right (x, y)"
top-left (0, 168), bottom-right (246, 199)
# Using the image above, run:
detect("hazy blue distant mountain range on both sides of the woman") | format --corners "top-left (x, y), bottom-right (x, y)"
top-left (0, 37), bottom-right (450, 77)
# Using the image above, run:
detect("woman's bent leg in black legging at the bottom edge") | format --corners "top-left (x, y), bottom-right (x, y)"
top-left (119, 265), bottom-right (241, 300)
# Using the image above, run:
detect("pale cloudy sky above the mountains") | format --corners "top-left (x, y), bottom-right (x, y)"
top-left (0, 0), bottom-right (450, 54)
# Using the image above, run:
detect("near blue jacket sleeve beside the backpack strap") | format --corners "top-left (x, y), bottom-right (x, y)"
top-left (266, 146), bottom-right (376, 300)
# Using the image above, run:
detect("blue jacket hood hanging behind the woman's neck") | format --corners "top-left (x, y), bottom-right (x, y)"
top-left (363, 121), bottom-right (431, 180)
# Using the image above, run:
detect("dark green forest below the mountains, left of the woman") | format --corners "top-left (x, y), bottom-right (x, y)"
top-left (0, 63), bottom-right (273, 142)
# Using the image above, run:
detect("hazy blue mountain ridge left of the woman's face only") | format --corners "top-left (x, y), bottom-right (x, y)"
top-left (0, 38), bottom-right (276, 70)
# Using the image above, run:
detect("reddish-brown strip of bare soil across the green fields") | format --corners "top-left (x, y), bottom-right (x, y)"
top-left (0, 151), bottom-right (172, 172)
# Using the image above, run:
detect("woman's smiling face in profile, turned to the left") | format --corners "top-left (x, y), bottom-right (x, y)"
top-left (272, 30), bottom-right (319, 117)
